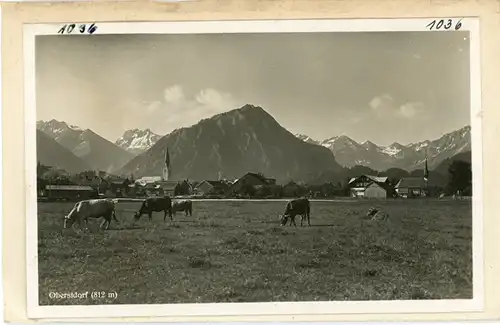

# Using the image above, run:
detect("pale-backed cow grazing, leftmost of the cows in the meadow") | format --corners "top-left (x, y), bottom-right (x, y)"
top-left (64, 199), bottom-right (119, 230)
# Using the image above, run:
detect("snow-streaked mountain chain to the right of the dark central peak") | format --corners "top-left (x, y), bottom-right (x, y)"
top-left (297, 126), bottom-right (471, 171)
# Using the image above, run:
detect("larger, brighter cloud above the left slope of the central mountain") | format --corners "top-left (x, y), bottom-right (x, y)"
top-left (142, 85), bottom-right (243, 133)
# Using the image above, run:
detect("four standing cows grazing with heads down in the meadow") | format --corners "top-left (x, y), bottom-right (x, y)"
top-left (64, 196), bottom-right (311, 230)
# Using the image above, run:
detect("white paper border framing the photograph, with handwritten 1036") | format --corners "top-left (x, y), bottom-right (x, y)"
top-left (23, 17), bottom-right (484, 318)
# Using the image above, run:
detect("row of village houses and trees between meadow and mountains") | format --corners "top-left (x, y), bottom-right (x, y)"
top-left (37, 163), bottom-right (438, 201)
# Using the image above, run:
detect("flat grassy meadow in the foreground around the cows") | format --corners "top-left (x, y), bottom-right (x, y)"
top-left (38, 200), bottom-right (472, 305)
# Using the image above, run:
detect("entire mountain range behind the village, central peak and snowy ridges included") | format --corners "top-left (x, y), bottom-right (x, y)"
top-left (37, 104), bottom-right (471, 182)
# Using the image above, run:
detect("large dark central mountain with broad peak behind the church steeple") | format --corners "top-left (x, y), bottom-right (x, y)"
top-left (121, 105), bottom-right (342, 182)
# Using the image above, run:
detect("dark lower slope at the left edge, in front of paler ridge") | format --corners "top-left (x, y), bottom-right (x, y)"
top-left (36, 130), bottom-right (91, 173)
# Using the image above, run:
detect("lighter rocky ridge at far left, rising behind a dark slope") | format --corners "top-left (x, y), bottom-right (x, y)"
top-left (37, 120), bottom-right (133, 172)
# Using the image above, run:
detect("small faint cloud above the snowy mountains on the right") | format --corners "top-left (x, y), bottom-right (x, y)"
top-left (368, 94), bottom-right (425, 119)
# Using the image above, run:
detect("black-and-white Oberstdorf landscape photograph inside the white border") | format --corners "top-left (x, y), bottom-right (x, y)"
top-left (26, 20), bottom-right (481, 316)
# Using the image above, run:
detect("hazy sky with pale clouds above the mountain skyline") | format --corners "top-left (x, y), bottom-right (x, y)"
top-left (35, 31), bottom-right (470, 145)
